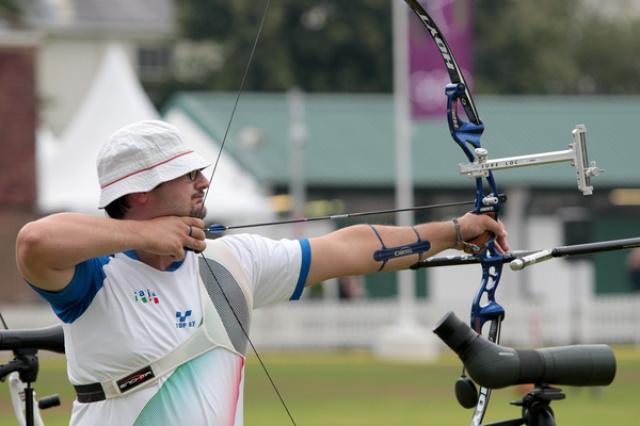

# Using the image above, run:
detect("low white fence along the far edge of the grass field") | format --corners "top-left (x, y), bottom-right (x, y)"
top-left (0, 294), bottom-right (640, 349)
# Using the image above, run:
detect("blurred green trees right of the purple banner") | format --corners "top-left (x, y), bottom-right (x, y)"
top-left (475, 0), bottom-right (640, 94)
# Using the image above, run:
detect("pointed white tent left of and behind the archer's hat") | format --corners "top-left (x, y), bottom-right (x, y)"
top-left (37, 44), bottom-right (159, 215)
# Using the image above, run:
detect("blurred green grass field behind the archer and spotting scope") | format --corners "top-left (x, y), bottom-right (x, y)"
top-left (0, 347), bottom-right (640, 426)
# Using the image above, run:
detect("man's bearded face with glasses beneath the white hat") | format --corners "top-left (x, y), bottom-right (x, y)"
top-left (150, 170), bottom-right (209, 219)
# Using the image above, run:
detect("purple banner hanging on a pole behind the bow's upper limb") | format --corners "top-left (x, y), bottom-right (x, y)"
top-left (407, 0), bottom-right (473, 120)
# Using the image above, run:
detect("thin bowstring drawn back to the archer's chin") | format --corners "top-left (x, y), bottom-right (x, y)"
top-left (195, 0), bottom-right (296, 426)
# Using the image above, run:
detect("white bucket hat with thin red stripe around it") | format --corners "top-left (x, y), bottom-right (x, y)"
top-left (96, 120), bottom-right (210, 209)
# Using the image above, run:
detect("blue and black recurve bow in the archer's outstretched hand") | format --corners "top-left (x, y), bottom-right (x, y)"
top-left (405, 0), bottom-right (505, 425)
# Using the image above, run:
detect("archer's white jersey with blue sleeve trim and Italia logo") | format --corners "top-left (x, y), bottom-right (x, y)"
top-left (32, 234), bottom-right (311, 426)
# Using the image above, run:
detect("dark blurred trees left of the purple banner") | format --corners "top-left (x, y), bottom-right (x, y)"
top-left (171, 0), bottom-right (392, 92)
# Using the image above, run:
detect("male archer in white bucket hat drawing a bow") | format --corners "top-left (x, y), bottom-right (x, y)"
top-left (16, 121), bottom-right (508, 426)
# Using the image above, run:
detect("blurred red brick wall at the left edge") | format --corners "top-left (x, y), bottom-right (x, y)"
top-left (0, 44), bottom-right (39, 307)
